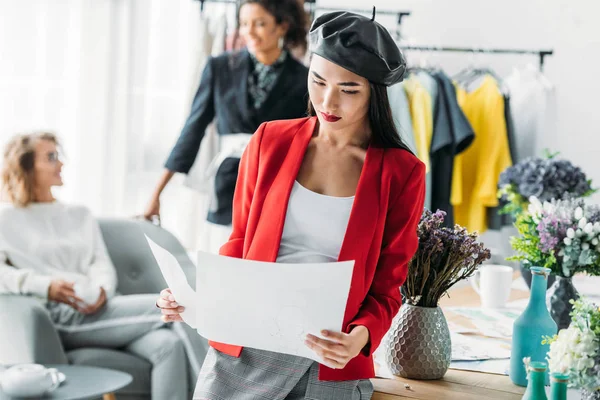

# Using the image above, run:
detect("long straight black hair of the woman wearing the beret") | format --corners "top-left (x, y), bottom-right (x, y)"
top-left (308, 82), bottom-right (412, 153)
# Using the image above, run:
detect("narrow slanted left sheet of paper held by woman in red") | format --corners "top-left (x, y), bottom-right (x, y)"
top-left (144, 235), bottom-right (197, 328)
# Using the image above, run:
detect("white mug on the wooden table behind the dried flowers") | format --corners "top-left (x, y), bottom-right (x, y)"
top-left (471, 264), bottom-right (514, 308)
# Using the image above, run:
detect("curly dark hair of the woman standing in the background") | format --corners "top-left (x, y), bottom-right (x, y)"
top-left (238, 0), bottom-right (308, 49)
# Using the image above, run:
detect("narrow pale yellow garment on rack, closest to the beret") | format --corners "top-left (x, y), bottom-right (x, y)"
top-left (404, 75), bottom-right (433, 172)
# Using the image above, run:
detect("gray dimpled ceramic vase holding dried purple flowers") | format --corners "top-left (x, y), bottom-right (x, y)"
top-left (384, 304), bottom-right (452, 379)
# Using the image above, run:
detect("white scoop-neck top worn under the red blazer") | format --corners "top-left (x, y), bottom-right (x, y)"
top-left (277, 181), bottom-right (354, 263)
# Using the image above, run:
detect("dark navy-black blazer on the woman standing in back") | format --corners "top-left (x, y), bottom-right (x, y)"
top-left (165, 49), bottom-right (308, 173)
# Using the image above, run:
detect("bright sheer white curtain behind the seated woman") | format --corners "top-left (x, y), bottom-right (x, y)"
top-left (0, 0), bottom-right (235, 249)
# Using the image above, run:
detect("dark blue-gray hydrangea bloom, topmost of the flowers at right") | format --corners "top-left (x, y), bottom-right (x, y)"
top-left (498, 154), bottom-right (595, 218)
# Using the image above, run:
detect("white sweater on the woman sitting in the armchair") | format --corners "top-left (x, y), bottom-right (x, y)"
top-left (0, 202), bottom-right (117, 299)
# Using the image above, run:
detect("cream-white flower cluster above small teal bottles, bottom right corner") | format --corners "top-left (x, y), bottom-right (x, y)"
top-left (542, 299), bottom-right (600, 392)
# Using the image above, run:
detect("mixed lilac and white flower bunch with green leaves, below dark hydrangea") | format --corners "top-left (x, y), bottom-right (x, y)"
top-left (509, 197), bottom-right (600, 277)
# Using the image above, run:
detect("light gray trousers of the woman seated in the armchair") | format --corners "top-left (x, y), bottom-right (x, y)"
top-left (48, 294), bottom-right (206, 400)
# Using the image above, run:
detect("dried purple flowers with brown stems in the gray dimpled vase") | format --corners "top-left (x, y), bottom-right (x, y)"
top-left (403, 210), bottom-right (491, 307)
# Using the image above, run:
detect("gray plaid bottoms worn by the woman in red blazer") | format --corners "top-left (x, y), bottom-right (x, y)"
top-left (194, 347), bottom-right (373, 400)
